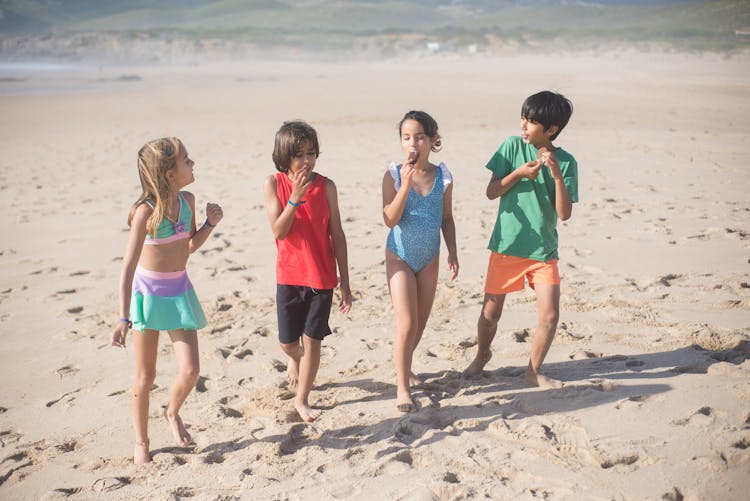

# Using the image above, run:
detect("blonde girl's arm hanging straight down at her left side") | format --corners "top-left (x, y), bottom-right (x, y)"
top-left (112, 204), bottom-right (153, 348)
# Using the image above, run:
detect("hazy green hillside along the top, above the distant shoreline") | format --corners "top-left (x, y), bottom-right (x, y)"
top-left (0, 0), bottom-right (750, 49)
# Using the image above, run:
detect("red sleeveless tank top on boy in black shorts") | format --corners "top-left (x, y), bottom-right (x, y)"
top-left (276, 172), bottom-right (338, 289)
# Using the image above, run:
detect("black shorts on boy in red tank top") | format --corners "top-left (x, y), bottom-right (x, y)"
top-left (276, 284), bottom-right (333, 344)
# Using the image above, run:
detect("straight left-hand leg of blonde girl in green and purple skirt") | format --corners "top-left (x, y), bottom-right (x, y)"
top-left (131, 330), bottom-right (159, 464)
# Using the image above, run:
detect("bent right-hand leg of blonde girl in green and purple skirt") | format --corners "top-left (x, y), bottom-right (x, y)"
top-left (165, 330), bottom-right (200, 447)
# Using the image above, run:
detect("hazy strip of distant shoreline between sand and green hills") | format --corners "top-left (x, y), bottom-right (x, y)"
top-left (0, 32), bottom-right (750, 69)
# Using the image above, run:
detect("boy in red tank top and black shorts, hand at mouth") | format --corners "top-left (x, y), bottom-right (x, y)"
top-left (263, 121), bottom-right (352, 422)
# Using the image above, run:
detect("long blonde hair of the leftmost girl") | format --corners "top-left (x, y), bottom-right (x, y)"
top-left (128, 137), bottom-right (185, 236)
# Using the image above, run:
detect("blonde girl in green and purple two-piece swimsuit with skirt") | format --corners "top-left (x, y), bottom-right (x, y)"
top-left (112, 137), bottom-right (223, 464)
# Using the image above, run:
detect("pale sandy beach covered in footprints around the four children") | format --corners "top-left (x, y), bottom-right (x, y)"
top-left (0, 49), bottom-right (750, 501)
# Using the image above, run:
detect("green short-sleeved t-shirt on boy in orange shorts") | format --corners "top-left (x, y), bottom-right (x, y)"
top-left (487, 136), bottom-right (578, 261)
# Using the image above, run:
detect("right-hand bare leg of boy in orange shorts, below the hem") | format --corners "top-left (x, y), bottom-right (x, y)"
top-left (526, 284), bottom-right (562, 388)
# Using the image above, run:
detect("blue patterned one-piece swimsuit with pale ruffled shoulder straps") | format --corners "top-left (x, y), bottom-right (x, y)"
top-left (386, 163), bottom-right (452, 273)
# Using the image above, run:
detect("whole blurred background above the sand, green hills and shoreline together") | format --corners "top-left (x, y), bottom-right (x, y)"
top-left (0, 0), bottom-right (750, 63)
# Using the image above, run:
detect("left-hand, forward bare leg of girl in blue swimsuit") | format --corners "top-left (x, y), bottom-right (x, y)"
top-left (385, 251), bottom-right (419, 412)
